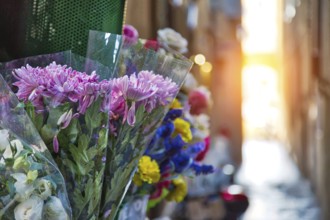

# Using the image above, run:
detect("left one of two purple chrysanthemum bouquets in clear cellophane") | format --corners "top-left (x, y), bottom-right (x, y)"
top-left (1, 51), bottom-right (111, 219)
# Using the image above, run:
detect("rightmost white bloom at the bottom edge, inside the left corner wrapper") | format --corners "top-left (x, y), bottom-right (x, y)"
top-left (44, 196), bottom-right (69, 220)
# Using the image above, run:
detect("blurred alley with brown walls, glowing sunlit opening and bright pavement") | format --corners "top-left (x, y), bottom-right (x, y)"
top-left (125, 0), bottom-right (330, 220)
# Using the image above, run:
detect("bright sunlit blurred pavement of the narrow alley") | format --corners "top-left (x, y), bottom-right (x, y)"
top-left (237, 140), bottom-right (321, 220)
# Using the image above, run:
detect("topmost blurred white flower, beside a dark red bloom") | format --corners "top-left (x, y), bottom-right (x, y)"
top-left (157, 28), bottom-right (188, 53)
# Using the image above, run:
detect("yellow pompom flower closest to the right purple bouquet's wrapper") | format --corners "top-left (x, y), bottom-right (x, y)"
top-left (133, 156), bottom-right (160, 186)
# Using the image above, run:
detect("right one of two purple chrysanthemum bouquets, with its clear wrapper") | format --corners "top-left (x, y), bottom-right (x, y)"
top-left (87, 31), bottom-right (192, 219)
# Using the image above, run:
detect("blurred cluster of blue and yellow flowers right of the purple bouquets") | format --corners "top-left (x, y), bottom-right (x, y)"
top-left (133, 97), bottom-right (213, 206)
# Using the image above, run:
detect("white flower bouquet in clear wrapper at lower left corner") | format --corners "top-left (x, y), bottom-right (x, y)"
top-left (0, 75), bottom-right (71, 220)
